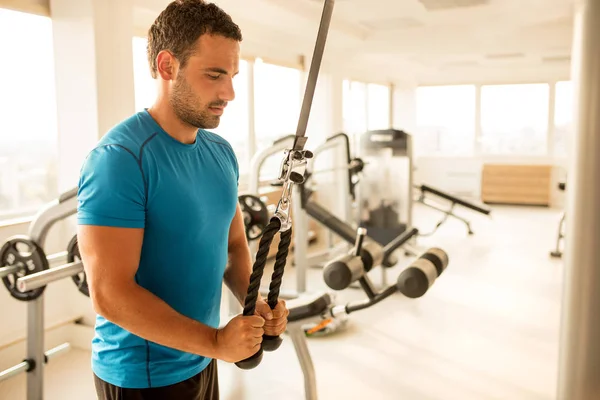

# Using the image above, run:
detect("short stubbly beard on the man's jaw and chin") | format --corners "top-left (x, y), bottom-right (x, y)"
top-left (169, 74), bottom-right (224, 129)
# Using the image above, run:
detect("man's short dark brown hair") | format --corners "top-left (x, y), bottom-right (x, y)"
top-left (147, 0), bottom-right (242, 79)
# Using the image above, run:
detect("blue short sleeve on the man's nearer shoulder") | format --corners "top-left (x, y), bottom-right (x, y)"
top-left (77, 145), bottom-right (146, 228)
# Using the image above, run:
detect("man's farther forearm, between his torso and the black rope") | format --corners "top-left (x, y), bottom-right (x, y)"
top-left (224, 243), bottom-right (255, 306)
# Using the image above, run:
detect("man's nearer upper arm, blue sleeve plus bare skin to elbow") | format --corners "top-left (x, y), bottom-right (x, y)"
top-left (77, 145), bottom-right (146, 308)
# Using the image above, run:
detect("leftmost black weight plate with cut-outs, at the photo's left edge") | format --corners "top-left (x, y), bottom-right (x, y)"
top-left (0, 236), bottom-right (50, 301)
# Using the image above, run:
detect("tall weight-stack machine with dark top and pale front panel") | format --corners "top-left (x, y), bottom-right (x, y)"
top-left (358, 129), bottom-right (413, 245)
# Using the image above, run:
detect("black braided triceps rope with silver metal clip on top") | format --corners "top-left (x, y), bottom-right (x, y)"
top-left (236, 150), bottom-right (313, 369)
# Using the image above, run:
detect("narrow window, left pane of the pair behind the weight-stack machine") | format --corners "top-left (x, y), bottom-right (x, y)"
top-left (342, 80), bottom-right (368, 154)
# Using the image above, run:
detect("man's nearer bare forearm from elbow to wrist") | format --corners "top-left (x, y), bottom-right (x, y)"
top-left (95, 283), bottom-right (219, 358)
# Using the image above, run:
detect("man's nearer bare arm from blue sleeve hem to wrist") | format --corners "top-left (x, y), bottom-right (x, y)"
top-left (78, 225), bottom-right (219, 358)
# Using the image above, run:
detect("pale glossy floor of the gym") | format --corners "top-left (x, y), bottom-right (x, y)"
top-left (0, 203), bottom-right (563, 400)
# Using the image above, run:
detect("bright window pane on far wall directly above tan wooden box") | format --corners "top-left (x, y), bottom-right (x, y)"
top-left (481, 84), bottom-right (550, 155)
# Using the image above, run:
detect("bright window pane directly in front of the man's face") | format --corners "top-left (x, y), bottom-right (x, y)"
top-left (211, 60), bottom-right (250, 176)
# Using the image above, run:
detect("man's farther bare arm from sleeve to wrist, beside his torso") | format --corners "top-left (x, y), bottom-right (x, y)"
top-left (224, 204), bottom-right (255, 306)
